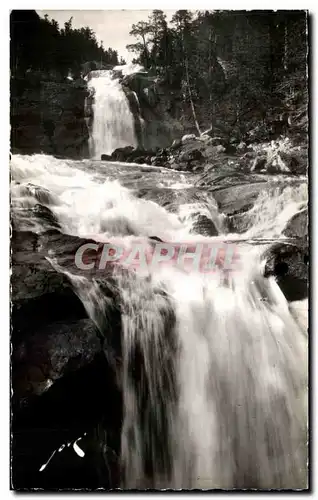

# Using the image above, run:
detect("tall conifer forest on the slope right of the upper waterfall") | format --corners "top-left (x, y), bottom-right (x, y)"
top-left (127, 10), bottom-right (308, 139)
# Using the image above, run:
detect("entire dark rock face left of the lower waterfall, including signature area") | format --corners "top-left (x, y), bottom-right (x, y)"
top-left (11, 230), bottom-right (122, 489)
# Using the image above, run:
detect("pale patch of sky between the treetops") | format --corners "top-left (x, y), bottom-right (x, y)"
top-left (37, 10), bottom-right (175, 62)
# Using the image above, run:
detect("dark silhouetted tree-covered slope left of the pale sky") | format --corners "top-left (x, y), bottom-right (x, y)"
top-left (10, 10), bottom-right (124, 78)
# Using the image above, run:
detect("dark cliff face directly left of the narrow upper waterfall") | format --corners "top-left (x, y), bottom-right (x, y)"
top-left (10, 75), bottom-right (88, 158)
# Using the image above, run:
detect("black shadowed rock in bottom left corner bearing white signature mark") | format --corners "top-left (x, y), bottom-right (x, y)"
top-left (11, 352), bottom-right (123, 490)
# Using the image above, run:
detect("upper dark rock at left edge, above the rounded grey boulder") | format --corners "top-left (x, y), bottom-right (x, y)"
top-left (11, 231), bottom-right (87, 339)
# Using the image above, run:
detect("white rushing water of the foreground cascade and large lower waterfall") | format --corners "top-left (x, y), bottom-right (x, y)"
top-left (11, 152), bottom-right (307, 489)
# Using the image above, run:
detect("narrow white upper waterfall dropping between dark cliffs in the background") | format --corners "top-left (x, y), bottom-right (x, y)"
top-left (88, 70), bottom-right (137, 159)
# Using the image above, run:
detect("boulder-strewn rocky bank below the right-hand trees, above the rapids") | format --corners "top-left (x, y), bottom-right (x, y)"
top-left (101, 135), bottom-right (308, 175)
